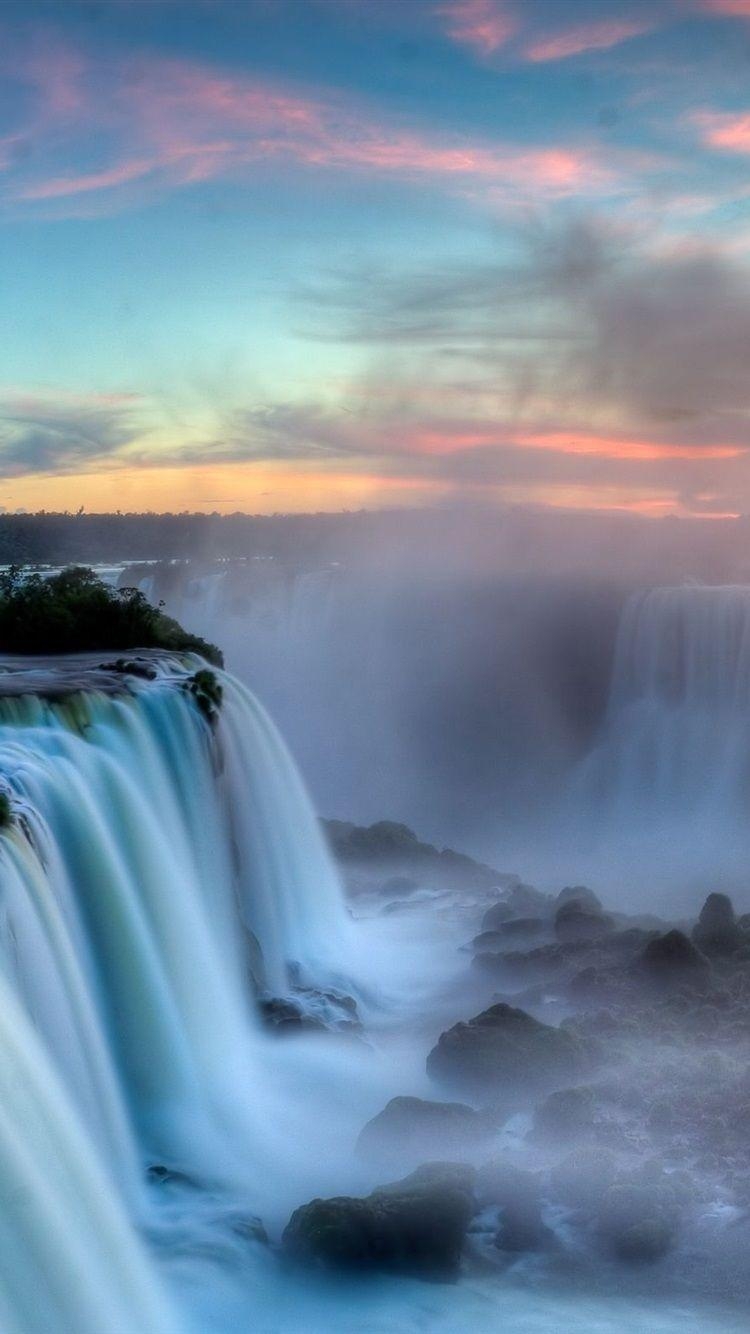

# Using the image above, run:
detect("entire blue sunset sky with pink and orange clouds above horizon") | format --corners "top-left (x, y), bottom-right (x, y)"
top-left (0, 0), bottom-right (750, 519)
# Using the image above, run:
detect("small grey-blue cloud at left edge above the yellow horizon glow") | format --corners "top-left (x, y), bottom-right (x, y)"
top-left (0, 391), bottom-right (143, 478)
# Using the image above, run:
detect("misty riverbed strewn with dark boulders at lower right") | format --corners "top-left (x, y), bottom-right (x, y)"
top-left (283, 826), bottom-right (750, 1302)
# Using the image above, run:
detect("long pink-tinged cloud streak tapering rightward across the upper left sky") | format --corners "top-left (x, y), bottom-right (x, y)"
top-left (5, 46), bottom-right (614, 201)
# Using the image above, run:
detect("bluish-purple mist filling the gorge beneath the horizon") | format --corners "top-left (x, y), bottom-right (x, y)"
top-left (120, 508), bottom-right (750, 907)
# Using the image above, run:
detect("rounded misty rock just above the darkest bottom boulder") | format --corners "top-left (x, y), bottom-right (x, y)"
top-left (356, 1097), bottom-right (498, 1161)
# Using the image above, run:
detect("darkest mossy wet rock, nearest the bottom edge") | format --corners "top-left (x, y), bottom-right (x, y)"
top-left (282, 1163), bottom-right (474, 1281)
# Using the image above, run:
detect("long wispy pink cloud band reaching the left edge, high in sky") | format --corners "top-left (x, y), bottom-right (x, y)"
top-left (0, 37), bottom-right (622, 211)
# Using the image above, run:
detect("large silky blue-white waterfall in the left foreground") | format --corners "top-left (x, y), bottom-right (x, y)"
top-left (0, 655), bottom-right (350, 1334)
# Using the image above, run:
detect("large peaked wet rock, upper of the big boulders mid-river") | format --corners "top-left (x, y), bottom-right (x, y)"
top-left (427, 1003), bottom-right (597, 1101)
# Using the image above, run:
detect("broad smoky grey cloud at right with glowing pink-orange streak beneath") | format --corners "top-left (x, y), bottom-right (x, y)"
top-left (269, 219), bottom-right (750, 512)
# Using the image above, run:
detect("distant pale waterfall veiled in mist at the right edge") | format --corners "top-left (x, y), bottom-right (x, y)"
top-left (566, 584), bottom-right (750, 882)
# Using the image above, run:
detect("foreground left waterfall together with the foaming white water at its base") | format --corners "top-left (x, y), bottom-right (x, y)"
top-left (0, 616), bottom-right (742, 1334)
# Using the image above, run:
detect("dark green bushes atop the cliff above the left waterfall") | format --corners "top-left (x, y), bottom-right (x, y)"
top-left (0, 566), bottom-right (222, 664)
